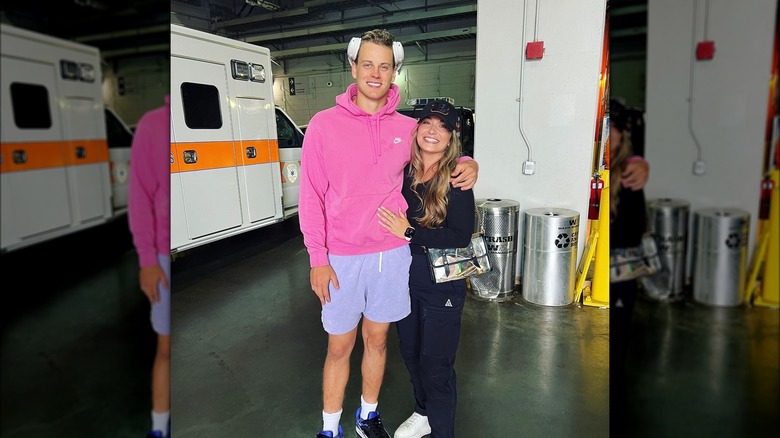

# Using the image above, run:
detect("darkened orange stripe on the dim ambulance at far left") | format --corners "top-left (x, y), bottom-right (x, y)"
top-left (0, 140), bottom-right (108, 172)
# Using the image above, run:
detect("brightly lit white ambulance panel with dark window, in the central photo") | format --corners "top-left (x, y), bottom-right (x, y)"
top-left (171, 55), bottom-right (241, 249)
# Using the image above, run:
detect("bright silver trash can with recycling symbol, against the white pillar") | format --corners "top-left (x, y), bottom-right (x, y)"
top-left (522, 207), bottom-right (580, 306)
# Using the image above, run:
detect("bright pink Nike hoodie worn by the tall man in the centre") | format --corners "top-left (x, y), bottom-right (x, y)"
top-left (298, 84), bottom-right (417, 267)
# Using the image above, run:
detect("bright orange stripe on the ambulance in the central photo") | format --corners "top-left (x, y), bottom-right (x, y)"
top-left (171, 140), bottom-right (279, 173)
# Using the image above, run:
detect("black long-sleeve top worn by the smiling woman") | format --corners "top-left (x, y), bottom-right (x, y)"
top-left (401, 166), bottom-right (476, 254)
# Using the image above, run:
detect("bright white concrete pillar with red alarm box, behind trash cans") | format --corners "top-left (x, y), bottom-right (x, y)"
top-left (475, 0), bottom-right (606, 284)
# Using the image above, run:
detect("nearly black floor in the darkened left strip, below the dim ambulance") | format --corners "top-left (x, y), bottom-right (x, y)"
top-left (0, 218), bottom-right (155, 438)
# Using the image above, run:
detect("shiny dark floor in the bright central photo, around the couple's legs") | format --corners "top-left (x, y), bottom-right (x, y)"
top-left (172, 219), bottom-right (609, 438)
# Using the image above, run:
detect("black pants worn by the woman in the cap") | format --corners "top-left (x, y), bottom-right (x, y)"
top-left (396, 254), bottom-right (466, 438)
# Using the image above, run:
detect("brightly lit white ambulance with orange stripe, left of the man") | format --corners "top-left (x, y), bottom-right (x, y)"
top-left (171, 24), bottom-right (303, 254)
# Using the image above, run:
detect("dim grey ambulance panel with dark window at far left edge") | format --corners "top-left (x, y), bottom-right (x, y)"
top-left (0, 56), bottom-right (73, 250)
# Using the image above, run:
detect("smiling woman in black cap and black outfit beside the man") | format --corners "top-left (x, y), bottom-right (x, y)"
top-left (379, 101), bottom-right (475, 438)
